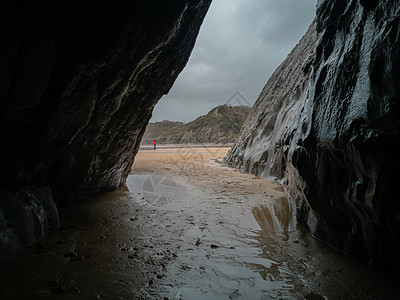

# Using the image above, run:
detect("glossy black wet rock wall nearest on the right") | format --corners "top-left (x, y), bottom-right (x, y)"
top-left (293, 1), bottom-right (400, 272)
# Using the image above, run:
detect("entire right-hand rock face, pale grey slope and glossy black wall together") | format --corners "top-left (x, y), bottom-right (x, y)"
top-left (226, 0), bottom-right (400, 274)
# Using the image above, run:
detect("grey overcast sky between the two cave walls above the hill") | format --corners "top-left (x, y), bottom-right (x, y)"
top-left (151, 0), bottom-right (316, 122)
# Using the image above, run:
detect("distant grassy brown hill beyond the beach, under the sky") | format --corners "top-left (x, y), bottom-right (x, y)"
top-left (142, 104), bottom-right (251, 145)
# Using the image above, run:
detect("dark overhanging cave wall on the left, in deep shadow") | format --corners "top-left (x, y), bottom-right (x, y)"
top-left (0, 0), bottom-right (211, 253)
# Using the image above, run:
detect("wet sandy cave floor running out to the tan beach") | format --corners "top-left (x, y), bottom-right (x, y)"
top-left (0, 147), bottom-right (400, 299)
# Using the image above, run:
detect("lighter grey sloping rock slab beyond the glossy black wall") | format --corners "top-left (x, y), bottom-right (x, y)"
top-left (225, 22), bottom-right (317, 178)
